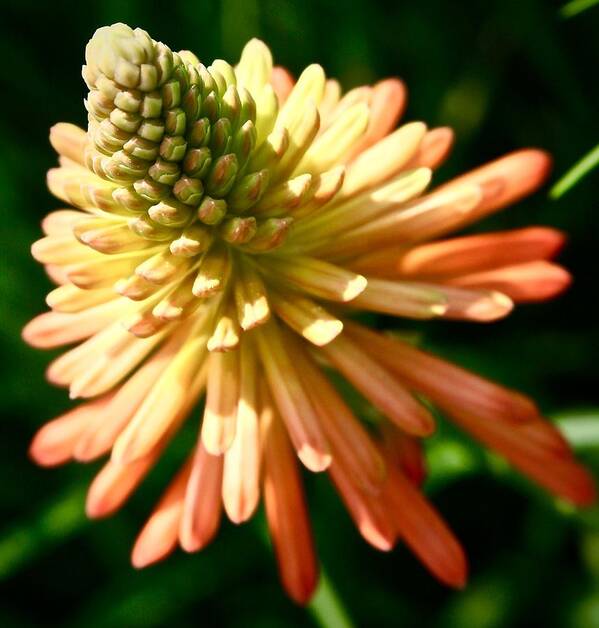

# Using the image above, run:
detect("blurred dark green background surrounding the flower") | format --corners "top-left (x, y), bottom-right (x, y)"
top-left (0, 0), bottom-right (599, 628)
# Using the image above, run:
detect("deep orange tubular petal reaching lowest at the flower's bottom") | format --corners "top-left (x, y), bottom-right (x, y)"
top-left (262, 402), bottom-right (318, 604)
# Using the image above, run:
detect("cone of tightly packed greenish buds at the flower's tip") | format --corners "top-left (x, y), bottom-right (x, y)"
top-left (75, 24), bottom-right (330, 258)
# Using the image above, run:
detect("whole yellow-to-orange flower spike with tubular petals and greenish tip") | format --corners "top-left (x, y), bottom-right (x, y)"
top-left (24, 24), bottom-right (594, 603)
